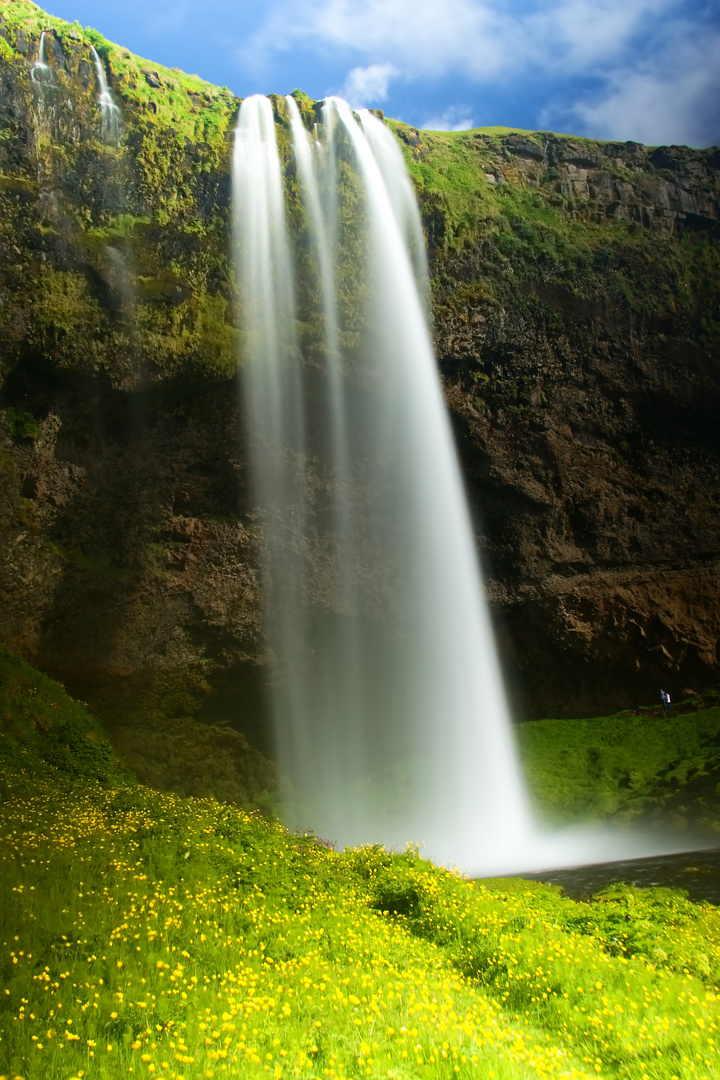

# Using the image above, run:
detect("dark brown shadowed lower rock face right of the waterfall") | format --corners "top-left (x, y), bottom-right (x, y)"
top-left (436, 319), bottom-right (720, 714)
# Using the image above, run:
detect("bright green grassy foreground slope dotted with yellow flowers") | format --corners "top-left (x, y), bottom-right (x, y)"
top-left (0, 650), bottom-right (720, 1080)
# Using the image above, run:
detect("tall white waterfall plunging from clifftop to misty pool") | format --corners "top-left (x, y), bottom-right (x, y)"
top-left (234, 96), bottom-right (708, 875)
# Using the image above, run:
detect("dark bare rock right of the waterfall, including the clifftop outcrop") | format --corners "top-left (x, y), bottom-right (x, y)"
top-left (427, 130), bottom-right (720, 715)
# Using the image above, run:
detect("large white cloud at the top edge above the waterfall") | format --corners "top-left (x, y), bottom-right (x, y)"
top-left (244, 0), bottom-right (682, 82)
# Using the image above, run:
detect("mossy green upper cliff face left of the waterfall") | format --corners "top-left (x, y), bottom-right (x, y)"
top-left (0, 0), bottom-right (237, 386)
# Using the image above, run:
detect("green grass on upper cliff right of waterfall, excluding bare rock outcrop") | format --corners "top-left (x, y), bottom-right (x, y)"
top-left (390, 121), bottom-right (720, 348)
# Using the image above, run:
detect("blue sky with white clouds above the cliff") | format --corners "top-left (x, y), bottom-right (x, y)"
top-left (41, 0), bottom-right (720, 147)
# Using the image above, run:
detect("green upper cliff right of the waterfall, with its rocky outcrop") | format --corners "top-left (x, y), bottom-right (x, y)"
top-left (390, 121), bottom-right (720, 346)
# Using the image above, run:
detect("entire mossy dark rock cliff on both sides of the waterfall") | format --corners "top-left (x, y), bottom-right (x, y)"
top-left (0, 0), bottom-right (720, 789)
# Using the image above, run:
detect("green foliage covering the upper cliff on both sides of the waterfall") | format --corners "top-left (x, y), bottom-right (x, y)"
top-left (0, 0), bottom-right (720, 395)
